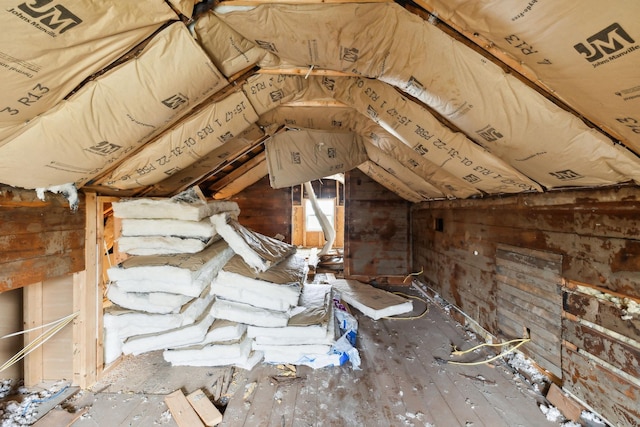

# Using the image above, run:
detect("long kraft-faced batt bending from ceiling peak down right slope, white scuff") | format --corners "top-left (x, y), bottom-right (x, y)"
top-left (220, 4), bottom-right (640, 188)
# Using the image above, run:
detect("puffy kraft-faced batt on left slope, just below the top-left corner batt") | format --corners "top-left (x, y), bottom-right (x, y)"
top-left (0, 23), bottom-right (227, 188)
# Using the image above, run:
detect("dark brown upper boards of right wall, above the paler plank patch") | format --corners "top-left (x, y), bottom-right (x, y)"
top-left (412, 187), bottom-right (640, 295)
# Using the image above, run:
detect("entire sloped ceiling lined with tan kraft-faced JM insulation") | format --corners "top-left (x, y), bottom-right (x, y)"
top-left (0, 0), bottom-right (640, 202)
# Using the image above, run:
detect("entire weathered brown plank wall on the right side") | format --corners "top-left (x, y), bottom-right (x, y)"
top-left (412, 186), bottom-right (640, 426)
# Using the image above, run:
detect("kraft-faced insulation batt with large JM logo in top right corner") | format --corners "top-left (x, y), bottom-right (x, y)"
top-left (417, 0), bottom-right (640, 154)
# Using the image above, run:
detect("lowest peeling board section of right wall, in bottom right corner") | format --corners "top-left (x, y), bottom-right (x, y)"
top-left (562, 346), bottom-right (640, 427)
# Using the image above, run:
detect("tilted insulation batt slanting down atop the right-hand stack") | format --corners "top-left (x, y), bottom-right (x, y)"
top-left (210, 213), bottom-right (296, 272)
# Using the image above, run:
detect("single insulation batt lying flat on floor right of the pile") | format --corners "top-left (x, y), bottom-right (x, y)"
top-left (331, 279), bottom-right (413, 320)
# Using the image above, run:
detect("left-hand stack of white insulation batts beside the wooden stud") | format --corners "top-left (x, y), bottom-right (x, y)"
top-left (104, 190), bottom-right (239, 363)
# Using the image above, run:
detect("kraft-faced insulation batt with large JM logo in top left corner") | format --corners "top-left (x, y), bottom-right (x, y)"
top-left (0, 0), bottom-right (178, 130)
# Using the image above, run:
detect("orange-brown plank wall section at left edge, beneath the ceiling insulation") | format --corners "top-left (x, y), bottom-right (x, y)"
top-left (0, 186), bottom-right (85, 292)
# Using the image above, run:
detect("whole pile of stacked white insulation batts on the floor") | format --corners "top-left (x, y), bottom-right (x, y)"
top-left (104, 190), bottom-right (355, 369)
